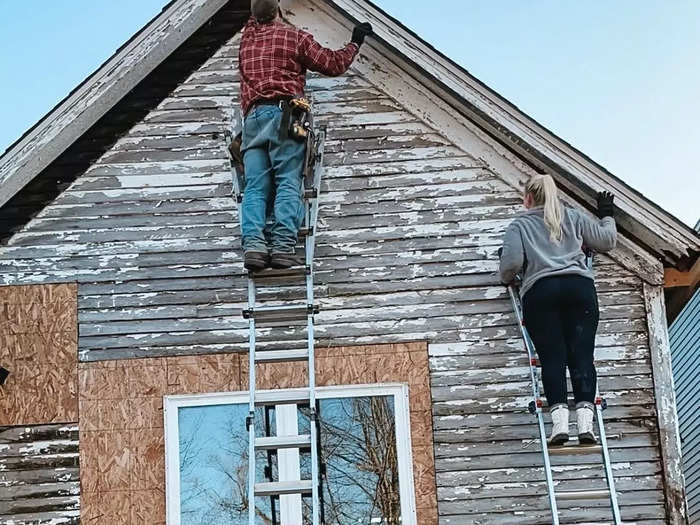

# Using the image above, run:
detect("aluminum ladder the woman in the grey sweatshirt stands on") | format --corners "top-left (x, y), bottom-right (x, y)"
top-left (508, 254), bottom-right (622, 525)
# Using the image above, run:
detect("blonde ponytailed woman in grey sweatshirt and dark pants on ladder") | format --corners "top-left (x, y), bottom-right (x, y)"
top-left (500, 175), bottom-right (617, 445)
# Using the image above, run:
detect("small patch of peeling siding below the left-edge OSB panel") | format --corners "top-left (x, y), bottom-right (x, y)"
top-left (0, 424), bottom-right (80, 525)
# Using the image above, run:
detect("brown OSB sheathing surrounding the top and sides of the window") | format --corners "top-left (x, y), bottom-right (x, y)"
top-left (78, 343), bottom-right (437, 525)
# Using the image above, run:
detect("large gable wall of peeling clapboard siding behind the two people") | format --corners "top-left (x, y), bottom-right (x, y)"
top-left (0, 29), bottom-right (665, 525)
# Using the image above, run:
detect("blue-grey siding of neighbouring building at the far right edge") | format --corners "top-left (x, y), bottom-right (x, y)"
top-left (669, 290), bottom-right (700, 524)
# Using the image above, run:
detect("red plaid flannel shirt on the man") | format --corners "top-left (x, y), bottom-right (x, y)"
top-left (238, 18), bottom-right (359, 115)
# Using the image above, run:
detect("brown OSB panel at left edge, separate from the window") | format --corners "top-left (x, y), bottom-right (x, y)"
top-left (0, 284), bottom-right (78, 426)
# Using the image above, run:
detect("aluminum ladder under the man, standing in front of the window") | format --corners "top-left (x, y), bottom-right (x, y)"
top-left (227, 110), bottom-right (326, 525)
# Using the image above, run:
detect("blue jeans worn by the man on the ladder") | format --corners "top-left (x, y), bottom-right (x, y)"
top-left (241, 106), bottom-right (306, 253)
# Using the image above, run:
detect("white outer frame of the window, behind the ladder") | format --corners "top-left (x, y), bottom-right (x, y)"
top-left (163, 383), bottom-right (418, 525)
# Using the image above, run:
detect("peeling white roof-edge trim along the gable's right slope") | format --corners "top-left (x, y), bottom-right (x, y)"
top-left (324, 0), bottom-right (700, 265)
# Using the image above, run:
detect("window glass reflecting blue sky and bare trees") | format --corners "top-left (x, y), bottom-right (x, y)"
top-left (178, 396), bottom-right (401, 525)
